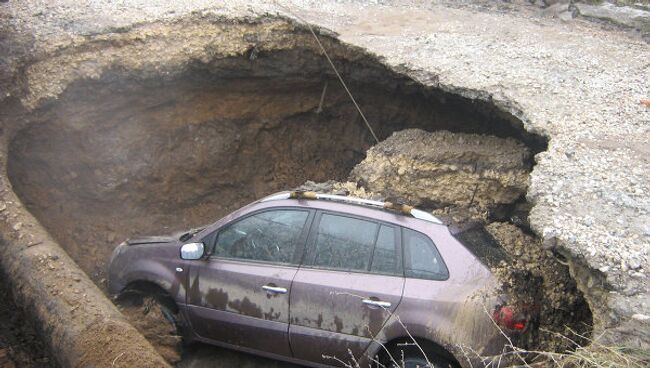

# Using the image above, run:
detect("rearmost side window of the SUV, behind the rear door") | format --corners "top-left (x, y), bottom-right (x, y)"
top-left (402, 229), bottom-right (449, 280)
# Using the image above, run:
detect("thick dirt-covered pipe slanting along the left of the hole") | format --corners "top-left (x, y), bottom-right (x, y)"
top-left (0, 133), bottom-right (166, 367)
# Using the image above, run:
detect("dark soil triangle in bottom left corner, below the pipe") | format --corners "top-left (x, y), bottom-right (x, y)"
top-left (0, 273), bottom-right (59, 368)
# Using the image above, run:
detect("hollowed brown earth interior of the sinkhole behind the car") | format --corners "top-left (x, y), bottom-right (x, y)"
top-left (8, 26), bottom-right (591, 366)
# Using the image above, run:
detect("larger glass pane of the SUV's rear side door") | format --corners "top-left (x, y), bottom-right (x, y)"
top-left (308, 213), bottom-right (379, 271)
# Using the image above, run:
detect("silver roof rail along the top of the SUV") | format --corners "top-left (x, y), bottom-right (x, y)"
top-left (260, 191), bottom-right (442, 225)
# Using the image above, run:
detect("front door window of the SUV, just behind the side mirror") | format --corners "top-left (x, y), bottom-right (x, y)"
top-left (212, 209), bottom-right (309, 263)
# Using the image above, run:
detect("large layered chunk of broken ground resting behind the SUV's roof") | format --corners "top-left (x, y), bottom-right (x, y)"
top-left (350, 129), bottom-right (530, 211)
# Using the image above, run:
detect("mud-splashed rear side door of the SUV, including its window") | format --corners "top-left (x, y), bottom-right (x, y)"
top-left (289, 212), bottom-right (404, 364)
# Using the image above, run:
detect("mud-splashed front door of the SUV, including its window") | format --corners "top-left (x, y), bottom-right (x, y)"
top-left (187, 208), bottom-right (313, 356)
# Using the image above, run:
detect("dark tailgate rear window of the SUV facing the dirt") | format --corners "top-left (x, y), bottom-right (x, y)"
top-left (454, 226), bottom-right (508, 268)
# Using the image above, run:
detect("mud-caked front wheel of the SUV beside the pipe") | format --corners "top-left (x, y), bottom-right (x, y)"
top-left (115, 290), bottom-right (183, 364)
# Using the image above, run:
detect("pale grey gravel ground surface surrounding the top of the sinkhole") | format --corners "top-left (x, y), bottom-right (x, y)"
top-left (0, 0), bottom-right (650, 348)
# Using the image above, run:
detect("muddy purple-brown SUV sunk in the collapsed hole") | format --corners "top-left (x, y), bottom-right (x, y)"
top-left (109, 192), bottom-right (529, 367)
